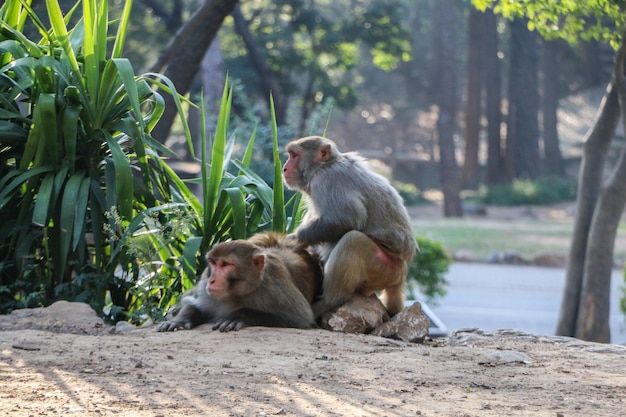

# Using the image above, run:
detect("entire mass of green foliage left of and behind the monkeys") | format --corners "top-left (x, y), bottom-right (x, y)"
top-left (0, 0), bottom-right (300, 321)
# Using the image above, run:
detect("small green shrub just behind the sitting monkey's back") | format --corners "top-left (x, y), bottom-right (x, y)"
top-left (407, 237), bottom-right (452, 302)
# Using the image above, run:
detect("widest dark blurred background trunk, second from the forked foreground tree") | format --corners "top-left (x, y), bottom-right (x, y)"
top-left (507, 19), bottom-right (541, 179)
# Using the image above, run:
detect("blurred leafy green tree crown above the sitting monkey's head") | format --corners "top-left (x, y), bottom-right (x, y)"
top-left (222, 0), bottom-right (411, 133)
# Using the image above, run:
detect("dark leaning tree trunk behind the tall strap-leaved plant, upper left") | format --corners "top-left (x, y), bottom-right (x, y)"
top-left (152, 0), bottom-right (238, 142)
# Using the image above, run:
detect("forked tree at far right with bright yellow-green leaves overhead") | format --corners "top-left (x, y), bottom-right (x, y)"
top-left (472, 0), bottom-right (626, 342)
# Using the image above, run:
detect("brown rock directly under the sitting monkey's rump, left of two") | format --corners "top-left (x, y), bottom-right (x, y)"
top-left (320, 295), bottom-right (389, 333)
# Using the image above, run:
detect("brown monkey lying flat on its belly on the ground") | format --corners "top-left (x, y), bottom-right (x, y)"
top-left (157, 234), bottom-right (322, 332)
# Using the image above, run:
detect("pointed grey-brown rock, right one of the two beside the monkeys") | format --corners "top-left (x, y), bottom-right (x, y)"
top-left (372, 301), bottom-right (430, 343)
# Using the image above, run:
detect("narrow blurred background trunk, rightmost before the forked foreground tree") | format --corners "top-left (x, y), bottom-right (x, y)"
top-left (541, 41), bottom-right (565, 176)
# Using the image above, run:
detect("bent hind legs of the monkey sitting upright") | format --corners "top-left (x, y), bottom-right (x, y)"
top-left (313, 230), bottom-right (406, 318)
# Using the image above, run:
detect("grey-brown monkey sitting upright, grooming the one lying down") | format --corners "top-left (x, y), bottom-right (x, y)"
top-left (283, 136), bottom-right (417, 318)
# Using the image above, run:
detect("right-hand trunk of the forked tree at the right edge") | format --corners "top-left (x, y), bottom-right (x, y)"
top-left (575, 31), bottom-right (626, 343)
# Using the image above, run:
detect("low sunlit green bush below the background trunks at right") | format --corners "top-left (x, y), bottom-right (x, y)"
top-left (477, 177), bottom-right (576, 206)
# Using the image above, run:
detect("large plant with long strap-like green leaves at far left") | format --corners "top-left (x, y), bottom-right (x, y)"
top-left (0, 0), bottom-right (195, 311)
